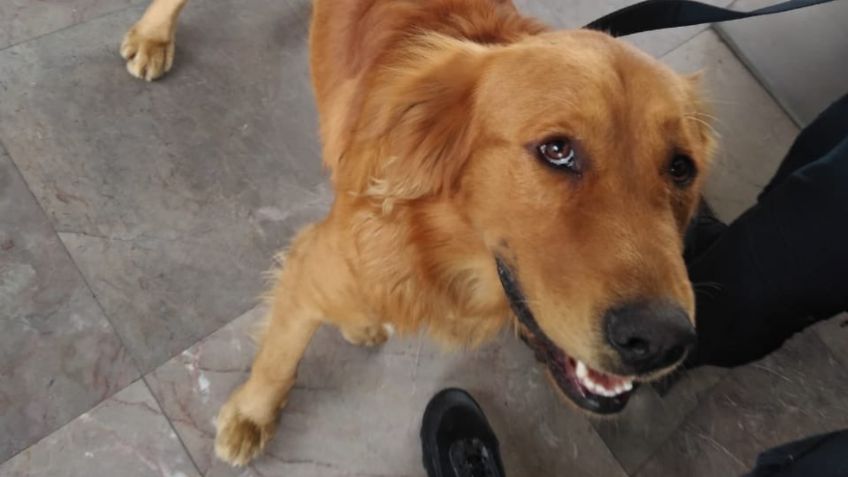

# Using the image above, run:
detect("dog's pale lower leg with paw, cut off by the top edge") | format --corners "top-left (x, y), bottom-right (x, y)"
top-left (121, 0), bottom-right (188, 81)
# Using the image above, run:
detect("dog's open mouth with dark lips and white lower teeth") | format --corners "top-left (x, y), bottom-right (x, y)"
top-left (496, 258), bottom-right (634, 414)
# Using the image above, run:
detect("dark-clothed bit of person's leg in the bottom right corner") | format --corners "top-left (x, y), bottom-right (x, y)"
top-left (746, 430), bottom-right (848, 477)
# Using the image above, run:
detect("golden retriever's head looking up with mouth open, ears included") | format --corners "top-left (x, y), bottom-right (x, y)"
top-left (368, 31), bottom-right (713, 413)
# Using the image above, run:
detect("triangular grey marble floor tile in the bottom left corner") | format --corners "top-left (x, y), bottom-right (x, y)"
top-left (0, 380), bottom-right (199, 477)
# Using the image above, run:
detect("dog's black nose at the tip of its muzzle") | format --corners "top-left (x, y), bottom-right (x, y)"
top-left (604, 300), bottom-right (695, 374)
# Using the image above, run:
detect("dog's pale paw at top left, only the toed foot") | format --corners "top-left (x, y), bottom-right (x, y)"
top-left (121, 24), bottom-right (175, 81)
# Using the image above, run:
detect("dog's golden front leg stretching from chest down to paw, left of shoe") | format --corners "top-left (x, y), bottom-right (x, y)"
top-left (215, 228), bottom-right (324, 466)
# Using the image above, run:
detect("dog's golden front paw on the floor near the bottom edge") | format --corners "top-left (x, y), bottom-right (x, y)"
top-left (215, 400), bottom-right (277, 467)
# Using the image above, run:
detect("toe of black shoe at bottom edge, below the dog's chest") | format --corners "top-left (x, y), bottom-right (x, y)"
top-left (421, 388), bottom-right (505, 477)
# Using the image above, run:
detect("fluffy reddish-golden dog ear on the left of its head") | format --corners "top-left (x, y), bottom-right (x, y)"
top-left (370, 36), bottom-right (487, 200)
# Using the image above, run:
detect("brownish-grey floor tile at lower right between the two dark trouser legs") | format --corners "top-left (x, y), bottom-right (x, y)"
top-left (638, 329), bottom-right (848, 477)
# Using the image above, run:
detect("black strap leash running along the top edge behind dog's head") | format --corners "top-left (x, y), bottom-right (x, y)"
top-left (585, 0), bottom-right (835, 36)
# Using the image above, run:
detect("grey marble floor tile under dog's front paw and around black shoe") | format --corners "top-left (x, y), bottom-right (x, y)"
top-left (148, 309), bottom-right (624, 477)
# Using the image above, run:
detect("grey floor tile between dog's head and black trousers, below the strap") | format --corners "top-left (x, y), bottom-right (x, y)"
top-left (662, 30), bottom-right (798, 220)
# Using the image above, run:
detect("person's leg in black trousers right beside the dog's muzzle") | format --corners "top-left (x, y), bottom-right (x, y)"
top-left (687, 98), bottom-right (848, 366)
